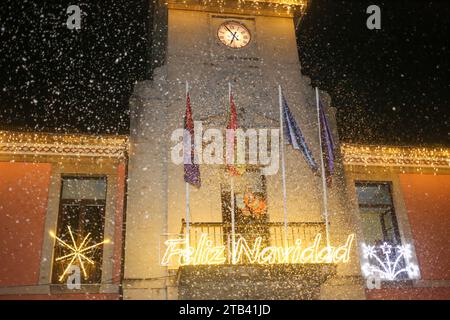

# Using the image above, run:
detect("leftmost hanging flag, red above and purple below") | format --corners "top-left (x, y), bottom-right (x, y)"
top-left (183, 91), bottom-right (201, 188)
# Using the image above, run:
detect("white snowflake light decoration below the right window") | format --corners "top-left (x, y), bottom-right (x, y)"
top-left (361, 242), bottom-right (419, 281)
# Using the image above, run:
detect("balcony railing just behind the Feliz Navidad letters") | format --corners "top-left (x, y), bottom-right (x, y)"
top-left (180, 219), bottom-right (325, 248)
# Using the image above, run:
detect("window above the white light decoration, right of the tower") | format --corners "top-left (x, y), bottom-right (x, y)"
top-left (356, 182), bottom-right (401, 245)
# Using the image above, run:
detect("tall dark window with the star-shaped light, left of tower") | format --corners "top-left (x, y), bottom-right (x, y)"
top-left (52, 176), bottom-right (106, 283)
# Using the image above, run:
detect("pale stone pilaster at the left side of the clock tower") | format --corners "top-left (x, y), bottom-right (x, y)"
top-left (123, 69), bottom-right (169, 299)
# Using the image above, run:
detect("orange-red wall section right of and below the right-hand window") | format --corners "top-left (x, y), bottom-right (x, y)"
top-left (366, 172), bottom-right (450, 300)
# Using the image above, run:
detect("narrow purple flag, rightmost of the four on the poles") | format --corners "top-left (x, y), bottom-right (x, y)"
top-left (319, 99), bottom-right (334, 187)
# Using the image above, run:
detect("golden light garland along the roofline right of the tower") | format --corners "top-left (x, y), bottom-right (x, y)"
top-left (341, 143), bottom-right (450, 169)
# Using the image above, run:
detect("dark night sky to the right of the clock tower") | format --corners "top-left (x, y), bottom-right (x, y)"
top-left (299, 0), bottom-right (450, 145)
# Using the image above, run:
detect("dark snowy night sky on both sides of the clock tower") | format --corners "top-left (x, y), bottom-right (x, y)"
top-left (0, 0), bottom-right (450, 146)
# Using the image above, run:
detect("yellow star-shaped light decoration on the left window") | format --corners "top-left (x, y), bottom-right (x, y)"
top-left (50, 226), bottom-right (110, 281)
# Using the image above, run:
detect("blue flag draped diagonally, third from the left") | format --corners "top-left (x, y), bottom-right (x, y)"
top-left (282, 96), bottom-right (318, 173)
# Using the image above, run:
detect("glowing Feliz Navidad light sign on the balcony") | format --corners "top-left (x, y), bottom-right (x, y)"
top-left (161, 233), bottom-right (355, 266)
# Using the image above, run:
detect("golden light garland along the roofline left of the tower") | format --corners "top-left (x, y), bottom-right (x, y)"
top-left (0, 131), bottom-right (129, 158)
